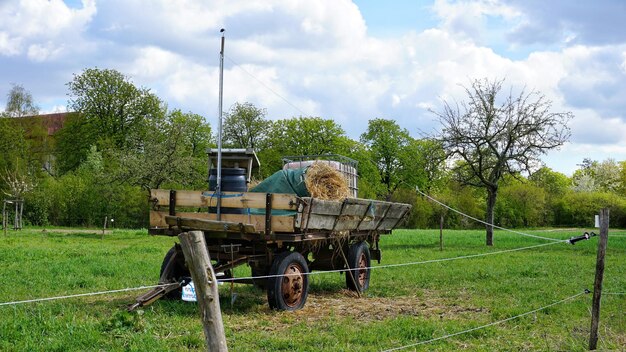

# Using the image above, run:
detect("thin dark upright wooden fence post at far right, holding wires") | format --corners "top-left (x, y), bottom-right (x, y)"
top-left (589, 208), bottom-right (609, 350)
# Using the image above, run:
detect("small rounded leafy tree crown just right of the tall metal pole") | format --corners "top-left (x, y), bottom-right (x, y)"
top-left (223, 102), bottom-right (271, 149)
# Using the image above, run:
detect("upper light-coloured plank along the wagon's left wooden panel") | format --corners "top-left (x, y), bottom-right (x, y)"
top-left (150, 189), bottom-right (297, 210)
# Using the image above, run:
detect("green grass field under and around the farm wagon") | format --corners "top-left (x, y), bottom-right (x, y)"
top-left (0, 229), bottom-right (626, 351)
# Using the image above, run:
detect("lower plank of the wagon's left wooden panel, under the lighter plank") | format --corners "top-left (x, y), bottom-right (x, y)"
top-left (150, 210), bottom-right (295, 233)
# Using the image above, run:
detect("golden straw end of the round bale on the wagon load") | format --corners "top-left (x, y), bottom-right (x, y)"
top-left (304, 162), bottom-right (350, 200)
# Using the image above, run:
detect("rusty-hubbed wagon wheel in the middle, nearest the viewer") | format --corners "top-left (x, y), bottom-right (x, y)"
top-left (267, 252), bottom-right (309, 311)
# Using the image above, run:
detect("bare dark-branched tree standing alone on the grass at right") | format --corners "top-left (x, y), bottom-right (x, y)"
top-left (433, 79), bottom-right (573, 246)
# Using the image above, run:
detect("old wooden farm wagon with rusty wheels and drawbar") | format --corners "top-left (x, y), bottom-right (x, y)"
top-left (134, 189), bottom-right (411, 310)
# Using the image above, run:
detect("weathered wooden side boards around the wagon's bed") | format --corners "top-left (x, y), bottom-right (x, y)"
top-left (150, 189), bottom-right (411, 236)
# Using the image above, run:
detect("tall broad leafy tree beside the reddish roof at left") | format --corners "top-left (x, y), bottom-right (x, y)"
top-left (67, 68), bottom-right (165, 149)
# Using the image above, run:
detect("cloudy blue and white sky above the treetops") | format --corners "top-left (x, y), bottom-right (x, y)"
top-left (0, 0), bottom-right (626, 174)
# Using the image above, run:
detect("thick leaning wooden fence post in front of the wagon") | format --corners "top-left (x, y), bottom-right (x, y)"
top-left (178, 231), bottom-right (228, 352)
